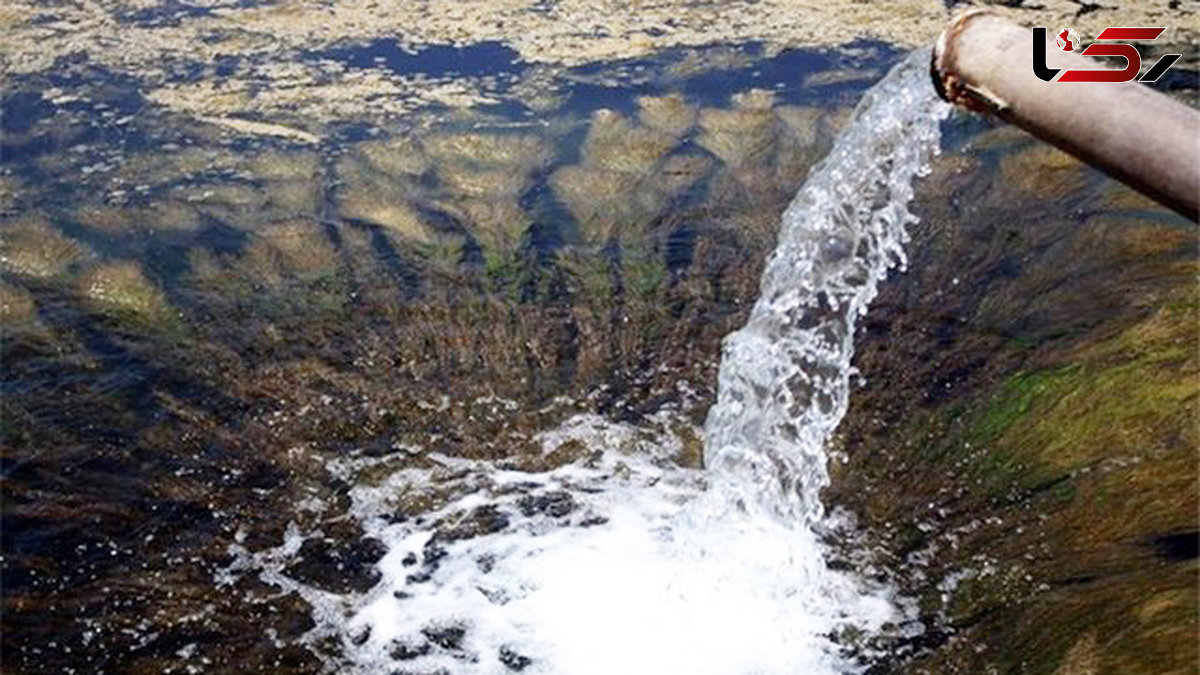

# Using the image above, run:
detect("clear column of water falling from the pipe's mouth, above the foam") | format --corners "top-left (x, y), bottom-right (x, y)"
top-left (706, 50), bottom-right (949, 524)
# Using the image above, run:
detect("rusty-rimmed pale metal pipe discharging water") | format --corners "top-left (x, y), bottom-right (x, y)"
top-left (931, 10), bottom-right (1200, 220)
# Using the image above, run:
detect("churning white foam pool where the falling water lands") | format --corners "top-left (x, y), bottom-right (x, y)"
top-left (328, 414), bottom-right (895, 674)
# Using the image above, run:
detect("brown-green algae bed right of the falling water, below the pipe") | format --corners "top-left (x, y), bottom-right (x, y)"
top-left (827, 120), bottom-right (1200, 675)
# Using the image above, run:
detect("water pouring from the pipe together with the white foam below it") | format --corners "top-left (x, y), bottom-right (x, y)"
top-left (227, 48), bottom-right (948, 674)
